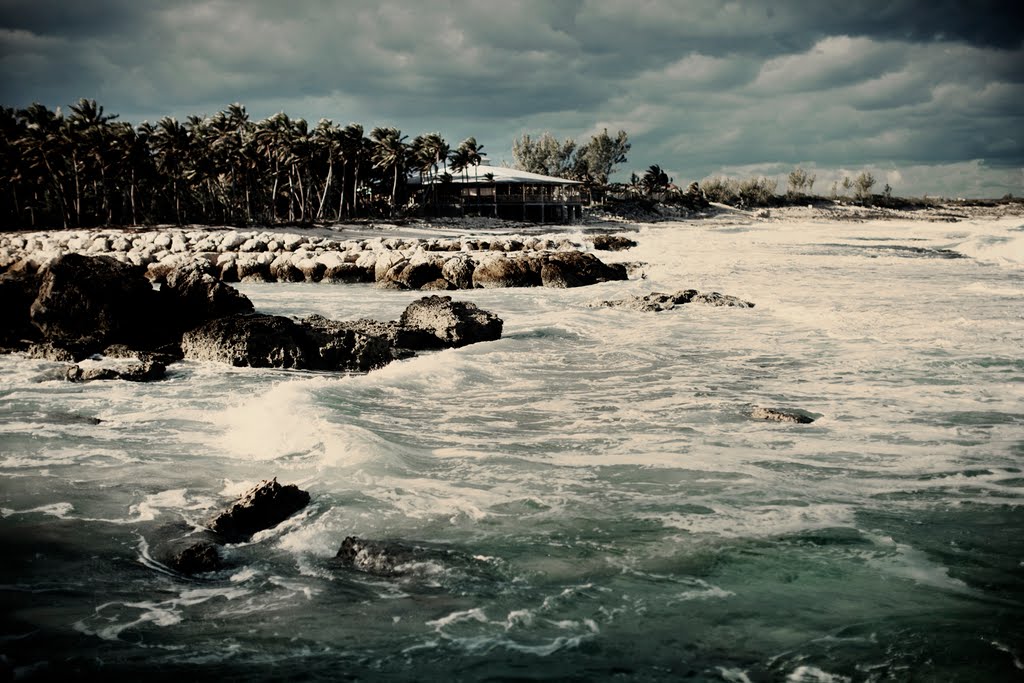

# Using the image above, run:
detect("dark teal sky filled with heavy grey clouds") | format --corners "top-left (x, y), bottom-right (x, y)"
top-left (0, 0), bottom-right (1024, 197)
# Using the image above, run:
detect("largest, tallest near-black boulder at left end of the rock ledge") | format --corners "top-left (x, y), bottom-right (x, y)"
top-left (31, 254), bottom-right (159, 350)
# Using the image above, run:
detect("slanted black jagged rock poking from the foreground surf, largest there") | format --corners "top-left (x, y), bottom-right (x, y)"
top-left (209, 478), bottom-right (309, 543)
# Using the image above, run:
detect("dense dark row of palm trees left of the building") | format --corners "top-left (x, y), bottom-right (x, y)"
top-left (0, 99), bottom-right (491, 228)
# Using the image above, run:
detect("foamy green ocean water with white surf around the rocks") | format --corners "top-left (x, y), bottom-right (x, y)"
top-left (0, 216), bottom-right (1024, 683)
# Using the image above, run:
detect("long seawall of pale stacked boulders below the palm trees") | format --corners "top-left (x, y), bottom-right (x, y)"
top-left (0, 228), bottom-right (628, 290)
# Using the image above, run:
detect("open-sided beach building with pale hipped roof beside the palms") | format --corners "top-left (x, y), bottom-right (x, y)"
top-left (409, 162), bottom-right (584, 223)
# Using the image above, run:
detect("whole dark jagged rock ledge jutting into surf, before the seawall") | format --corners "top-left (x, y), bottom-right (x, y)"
top-left (0, 254), bottom-right (503, 381)
